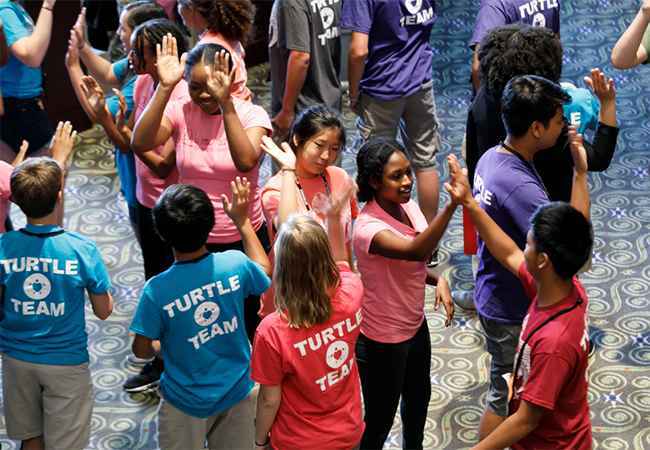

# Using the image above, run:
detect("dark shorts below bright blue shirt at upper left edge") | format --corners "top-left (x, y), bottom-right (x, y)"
top-left (0, 97), bottom-right (54, 155)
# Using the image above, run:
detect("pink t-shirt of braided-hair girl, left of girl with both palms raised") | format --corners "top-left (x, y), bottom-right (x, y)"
top-left (133, 76), bottom-right (185, 208)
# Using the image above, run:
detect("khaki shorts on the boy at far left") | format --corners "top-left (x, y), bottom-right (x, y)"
top-left (2, 353), bottom-right (95, 450)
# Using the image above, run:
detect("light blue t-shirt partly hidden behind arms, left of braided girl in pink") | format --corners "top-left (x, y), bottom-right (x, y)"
top-left (106, 58), bottom-right (138, 208)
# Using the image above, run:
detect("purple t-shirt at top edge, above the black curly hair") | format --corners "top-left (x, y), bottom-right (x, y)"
top-left (470, 0), bottom-right (560, 48)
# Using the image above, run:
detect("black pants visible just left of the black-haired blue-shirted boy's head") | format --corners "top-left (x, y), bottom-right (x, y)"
top-left (138, 202), bottom-right (174, 280)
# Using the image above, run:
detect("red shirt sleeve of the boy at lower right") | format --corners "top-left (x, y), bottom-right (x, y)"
top-left (521, 350), bottom-right (573, 409)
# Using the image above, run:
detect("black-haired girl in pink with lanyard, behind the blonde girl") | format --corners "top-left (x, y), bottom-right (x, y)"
top-left (259, 106), bottom-right (359, 317)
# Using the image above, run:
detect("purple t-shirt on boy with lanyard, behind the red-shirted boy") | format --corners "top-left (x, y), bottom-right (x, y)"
top-left (474, 146), bottom-right (548, 323)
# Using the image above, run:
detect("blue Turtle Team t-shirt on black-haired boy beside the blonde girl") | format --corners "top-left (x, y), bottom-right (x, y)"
top-left (131, 250), bottom-right (271, 418)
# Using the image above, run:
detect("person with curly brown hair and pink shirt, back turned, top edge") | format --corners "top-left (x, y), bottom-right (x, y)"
top-left (178, 0), bottom-right (255, 102)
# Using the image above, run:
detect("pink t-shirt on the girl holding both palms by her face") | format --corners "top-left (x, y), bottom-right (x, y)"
top-left (165, 97), bottom-right (272, 244)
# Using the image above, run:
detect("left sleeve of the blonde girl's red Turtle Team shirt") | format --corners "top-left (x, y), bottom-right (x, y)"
top-left (251, 316), bottom-right (284, 386)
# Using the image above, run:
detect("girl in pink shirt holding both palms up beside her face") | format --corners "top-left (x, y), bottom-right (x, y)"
top-left (132, 36), bottom-right (272, 342)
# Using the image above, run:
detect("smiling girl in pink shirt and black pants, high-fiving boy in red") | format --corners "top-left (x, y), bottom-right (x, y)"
top-left (353, 138), bottom-right (456, 450)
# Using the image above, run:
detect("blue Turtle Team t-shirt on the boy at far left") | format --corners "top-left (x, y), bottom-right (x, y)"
top-left (0, 225), bottom-right (111, 366)
